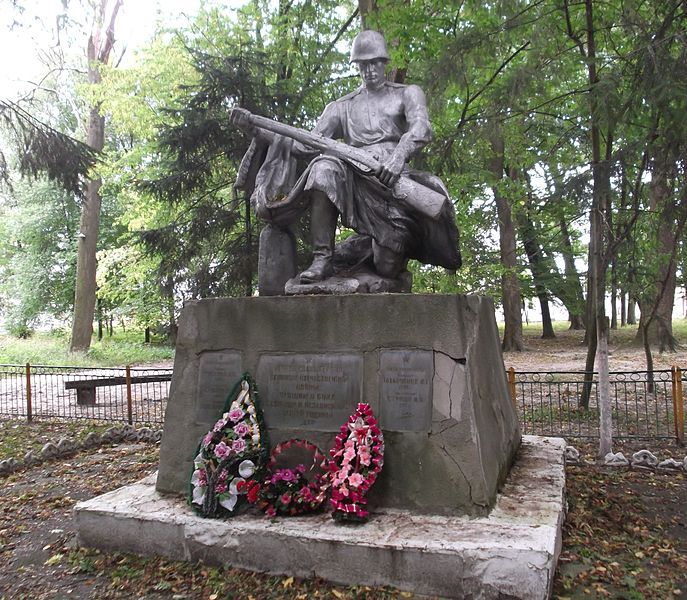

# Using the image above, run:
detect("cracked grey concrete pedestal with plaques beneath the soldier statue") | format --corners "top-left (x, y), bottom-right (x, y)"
top-left (157, 294), bottom-right (520, 516)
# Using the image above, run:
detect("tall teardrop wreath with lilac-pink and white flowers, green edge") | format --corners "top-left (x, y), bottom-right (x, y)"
top-left (194, 373), bottom-right (268, 517)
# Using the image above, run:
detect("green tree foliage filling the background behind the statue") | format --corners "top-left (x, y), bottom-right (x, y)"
top-left (0, 0), bottom-right (687, 334)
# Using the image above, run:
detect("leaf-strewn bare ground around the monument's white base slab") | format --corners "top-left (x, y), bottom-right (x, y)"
top-left (0, 422), bottom-right (687, 600)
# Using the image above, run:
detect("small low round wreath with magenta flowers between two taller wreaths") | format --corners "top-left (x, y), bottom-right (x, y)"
top-left (247, 438), bottom-right (329, 517)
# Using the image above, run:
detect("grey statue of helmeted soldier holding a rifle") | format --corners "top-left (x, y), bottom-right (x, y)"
top-left (232, 30), bottom-right (461, 291)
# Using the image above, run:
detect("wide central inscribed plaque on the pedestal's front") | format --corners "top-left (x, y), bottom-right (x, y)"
top-left (256, 354), bottom-right (363, 431)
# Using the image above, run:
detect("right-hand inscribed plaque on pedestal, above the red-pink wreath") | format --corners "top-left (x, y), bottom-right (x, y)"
top-left (379, 350), bottom-right (434, 432)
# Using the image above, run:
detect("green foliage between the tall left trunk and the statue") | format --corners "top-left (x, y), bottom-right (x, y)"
top-left (97, 2), bottom-right (360, 310)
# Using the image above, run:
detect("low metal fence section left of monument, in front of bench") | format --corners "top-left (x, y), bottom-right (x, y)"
top-left (0, 364), bottom-right (172, 424)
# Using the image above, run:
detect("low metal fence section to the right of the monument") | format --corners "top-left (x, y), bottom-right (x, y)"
top-left (508, 367), bottom-right (684, 442)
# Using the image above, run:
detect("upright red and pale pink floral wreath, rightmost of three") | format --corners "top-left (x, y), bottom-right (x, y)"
top-left (329, 403), bottom-right (384, 522)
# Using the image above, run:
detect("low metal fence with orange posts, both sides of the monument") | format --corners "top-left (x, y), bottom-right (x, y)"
top-left (0, 364), bottom-right (685, 443)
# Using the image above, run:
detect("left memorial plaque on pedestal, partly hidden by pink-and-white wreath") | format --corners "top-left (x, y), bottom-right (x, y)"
top-left (196, 350), bottom-right (243, 424)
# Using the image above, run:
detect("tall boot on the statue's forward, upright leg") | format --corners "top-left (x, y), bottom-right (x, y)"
top-left (299, 192), bottom-right (339, 283)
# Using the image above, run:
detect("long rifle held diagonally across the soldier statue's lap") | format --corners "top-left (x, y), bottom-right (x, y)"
top-left (230, 108), bottom-right (446, 221)
